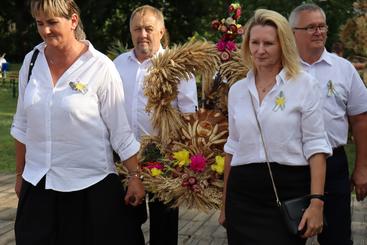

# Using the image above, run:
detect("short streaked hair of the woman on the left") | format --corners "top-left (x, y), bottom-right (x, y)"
top-left (31, 0), bottom-right (86, 40)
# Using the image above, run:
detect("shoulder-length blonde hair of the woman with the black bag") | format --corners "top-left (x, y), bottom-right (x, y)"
top-left (241, 9), bottom-right (301, 79)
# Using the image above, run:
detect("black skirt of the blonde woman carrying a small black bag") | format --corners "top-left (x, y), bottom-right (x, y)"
top-left (225, 163), bottom-right (310, 245)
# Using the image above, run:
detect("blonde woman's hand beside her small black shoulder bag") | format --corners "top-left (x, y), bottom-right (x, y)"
top-left (298, 198), bottom-right (324, 238)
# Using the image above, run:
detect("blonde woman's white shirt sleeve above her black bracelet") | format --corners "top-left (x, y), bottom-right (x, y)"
top-left (301, 80), bottom-right (332, 159)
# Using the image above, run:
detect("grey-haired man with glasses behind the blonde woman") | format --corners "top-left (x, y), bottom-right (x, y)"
top-left (289, 4), bottom-right (367, 245)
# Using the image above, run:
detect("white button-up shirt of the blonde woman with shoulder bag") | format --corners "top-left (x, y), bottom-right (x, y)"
top-left (224, 70), bottom-right (331, 166)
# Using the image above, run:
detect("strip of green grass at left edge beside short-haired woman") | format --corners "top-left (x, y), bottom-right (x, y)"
top-left (0, 89), bottom-right (17, 173)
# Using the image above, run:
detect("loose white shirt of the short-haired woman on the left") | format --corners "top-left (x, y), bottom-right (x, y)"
top-left (11, 41), bottom-right (140, 192)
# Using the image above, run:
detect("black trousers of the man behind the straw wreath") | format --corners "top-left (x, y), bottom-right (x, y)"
top-left (148, 194), bottom-right (178, 245)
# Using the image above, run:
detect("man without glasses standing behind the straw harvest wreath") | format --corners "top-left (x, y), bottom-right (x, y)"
top-left (114, 5), bottom-right (197, 245)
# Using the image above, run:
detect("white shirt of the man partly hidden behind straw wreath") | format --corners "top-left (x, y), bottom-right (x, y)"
top-left (114, 47), bottom-right (198, 140)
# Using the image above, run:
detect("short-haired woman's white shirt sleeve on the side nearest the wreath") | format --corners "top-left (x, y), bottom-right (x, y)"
top-left (100, 63), bottom-right (140, 160)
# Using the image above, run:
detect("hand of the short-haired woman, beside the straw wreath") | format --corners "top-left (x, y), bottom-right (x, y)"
top-left (125, 176), bottom-right (145, 206)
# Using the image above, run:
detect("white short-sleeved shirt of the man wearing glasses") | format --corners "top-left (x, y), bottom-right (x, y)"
top-left (302, 50), bottom-right (367, 148)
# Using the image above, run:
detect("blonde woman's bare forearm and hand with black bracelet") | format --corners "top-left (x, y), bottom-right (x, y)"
top-left (298, 153), bottom-right (326, 237)
